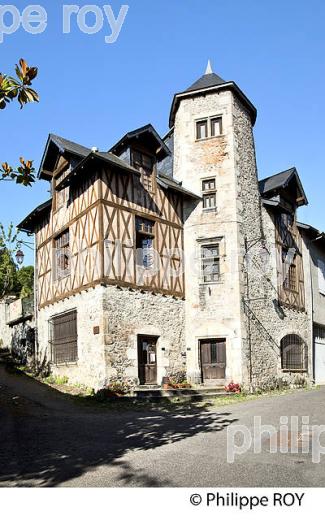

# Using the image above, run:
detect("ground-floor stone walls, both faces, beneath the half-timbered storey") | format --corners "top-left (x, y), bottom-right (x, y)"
top-left (38, 286), bottom-right (186, 390)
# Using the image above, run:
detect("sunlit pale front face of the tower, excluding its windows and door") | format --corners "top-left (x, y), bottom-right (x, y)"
top-left (174, 91), bottom-right (242, 384)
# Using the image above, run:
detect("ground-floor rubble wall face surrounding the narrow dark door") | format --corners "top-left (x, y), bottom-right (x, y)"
top-left (103, 286), bottom-right (186, 384)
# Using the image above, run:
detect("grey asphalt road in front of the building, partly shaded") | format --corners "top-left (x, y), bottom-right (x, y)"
top-left (0, 366), bottom-right (325, 487)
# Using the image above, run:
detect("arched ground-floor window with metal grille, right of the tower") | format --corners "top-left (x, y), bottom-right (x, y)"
top-left (280, 334), bottom-right (307, 371)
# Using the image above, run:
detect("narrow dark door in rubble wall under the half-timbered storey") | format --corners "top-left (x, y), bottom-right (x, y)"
top-left (138, 336), bottom-right (158, 385)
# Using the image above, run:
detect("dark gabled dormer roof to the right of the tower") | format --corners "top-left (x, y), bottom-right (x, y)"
top-left (259, 167), bottom-right (308, 206)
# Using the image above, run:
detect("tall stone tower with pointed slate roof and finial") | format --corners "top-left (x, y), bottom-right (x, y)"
top-left (170, 63), bottom-right (261, 384)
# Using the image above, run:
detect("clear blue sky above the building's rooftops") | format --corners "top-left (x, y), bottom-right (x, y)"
top-left (0, 0), bottom-right (325, 263)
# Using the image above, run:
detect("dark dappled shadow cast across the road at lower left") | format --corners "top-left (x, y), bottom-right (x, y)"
top-left (0, 366), bottom-right (236, 487)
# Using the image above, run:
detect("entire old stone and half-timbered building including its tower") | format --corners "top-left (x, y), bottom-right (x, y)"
top-left (19, 66), bottom-right (323, 388)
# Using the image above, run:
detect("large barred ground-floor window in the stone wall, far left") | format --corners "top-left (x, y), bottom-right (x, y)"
top-left (50, 310), bottom-right (78, 365)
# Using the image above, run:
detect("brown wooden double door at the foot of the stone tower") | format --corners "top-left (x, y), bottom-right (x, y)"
top-left (200, 339), bottom-right (226, 383)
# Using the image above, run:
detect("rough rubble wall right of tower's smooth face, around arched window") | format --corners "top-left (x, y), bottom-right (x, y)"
top-left (234, 100), bottom-right (312, 386)
